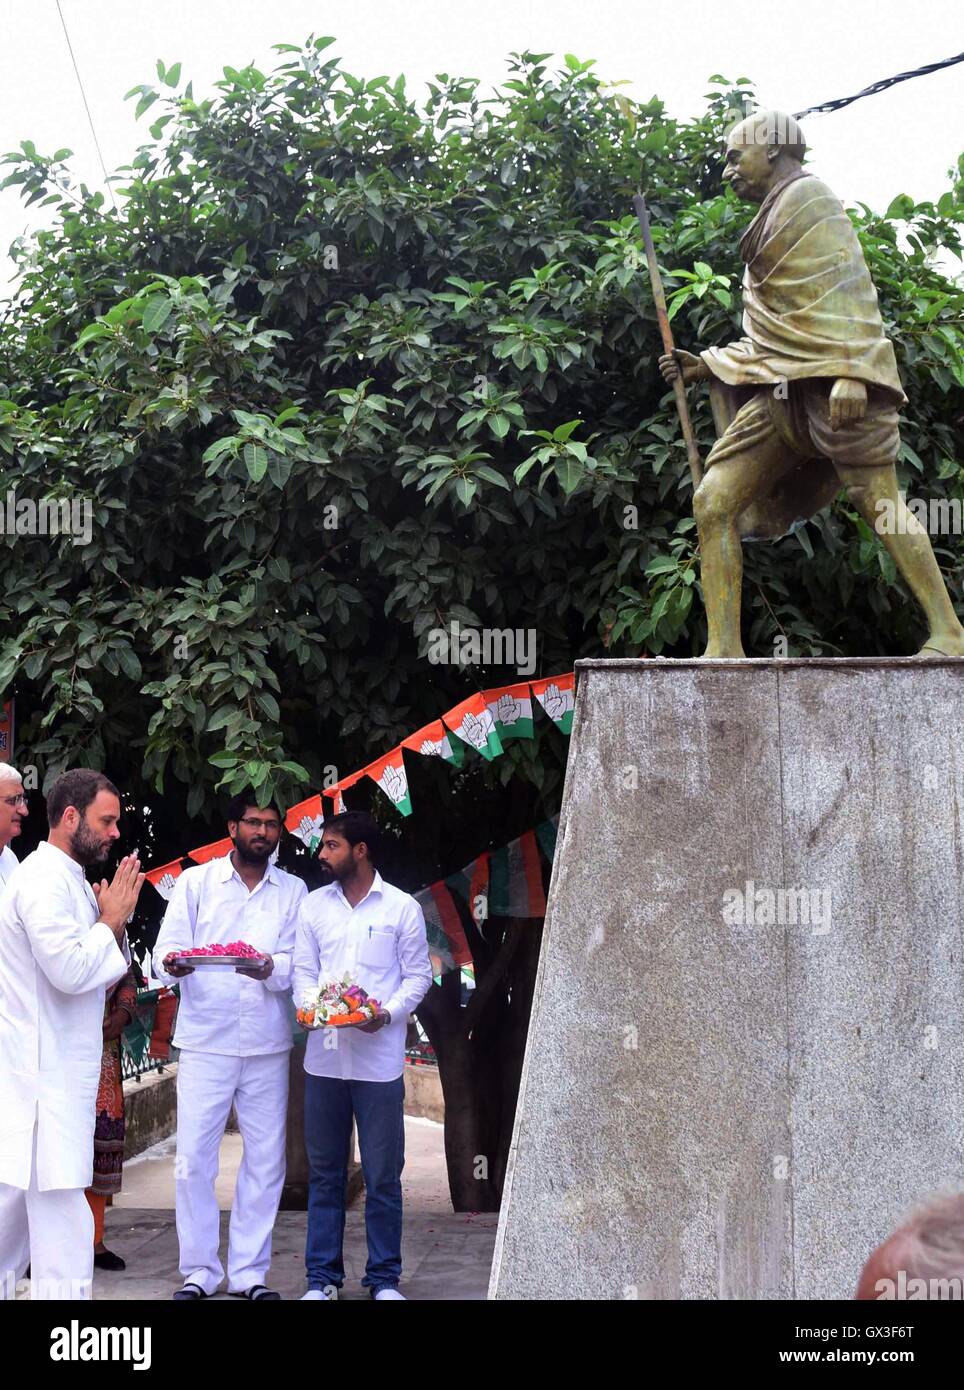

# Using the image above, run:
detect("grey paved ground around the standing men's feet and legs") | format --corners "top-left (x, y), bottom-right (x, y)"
top-left (94, 1116), bottom-right (497, 1302)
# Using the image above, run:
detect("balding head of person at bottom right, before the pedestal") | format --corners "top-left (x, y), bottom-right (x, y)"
top-left (854, 1193), bottom-right (964, 1301)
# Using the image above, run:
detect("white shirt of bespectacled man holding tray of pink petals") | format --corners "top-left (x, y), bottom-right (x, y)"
top-left (153, 855), bottom-right (307, 1056)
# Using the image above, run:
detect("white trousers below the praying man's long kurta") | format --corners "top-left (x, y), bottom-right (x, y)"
top-left (0, 1125), bottom-right (93, 1301)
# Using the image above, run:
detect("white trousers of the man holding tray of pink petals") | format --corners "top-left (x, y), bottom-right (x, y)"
top-left (174, 1049), bottom-right (288, 1294)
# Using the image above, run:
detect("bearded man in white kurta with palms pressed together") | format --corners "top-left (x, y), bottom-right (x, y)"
top-left (0, 769), bottom-right (143, 1298)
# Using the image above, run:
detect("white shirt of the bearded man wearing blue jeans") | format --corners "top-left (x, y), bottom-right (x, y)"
top-left (293, 873), bottom-right (432, 1081)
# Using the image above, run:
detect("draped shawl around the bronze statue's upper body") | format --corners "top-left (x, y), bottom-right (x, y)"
top-left (701, 170), bottom-right (907, 406)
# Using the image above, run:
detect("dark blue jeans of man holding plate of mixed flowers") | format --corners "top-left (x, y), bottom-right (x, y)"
top-left (304, 1073), bottom-right (406, 1294)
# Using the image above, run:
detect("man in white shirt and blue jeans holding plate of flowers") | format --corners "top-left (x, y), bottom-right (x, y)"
top-left (294, 810), bottom-right (432, 1301)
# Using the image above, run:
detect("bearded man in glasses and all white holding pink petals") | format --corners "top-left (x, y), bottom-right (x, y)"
top-left (153, 791), bottom-right (307, 1302)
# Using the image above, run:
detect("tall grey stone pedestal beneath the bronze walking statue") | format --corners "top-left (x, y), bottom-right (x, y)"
top-left (490, 659), bottom-right (964, 1298)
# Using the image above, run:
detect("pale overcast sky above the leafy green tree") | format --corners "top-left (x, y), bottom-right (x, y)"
top-left (0, 0), bottom-right (964, 290)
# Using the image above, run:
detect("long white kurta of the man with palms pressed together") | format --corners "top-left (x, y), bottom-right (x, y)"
top-left (0, 841), bottom-right (128, 1191)
